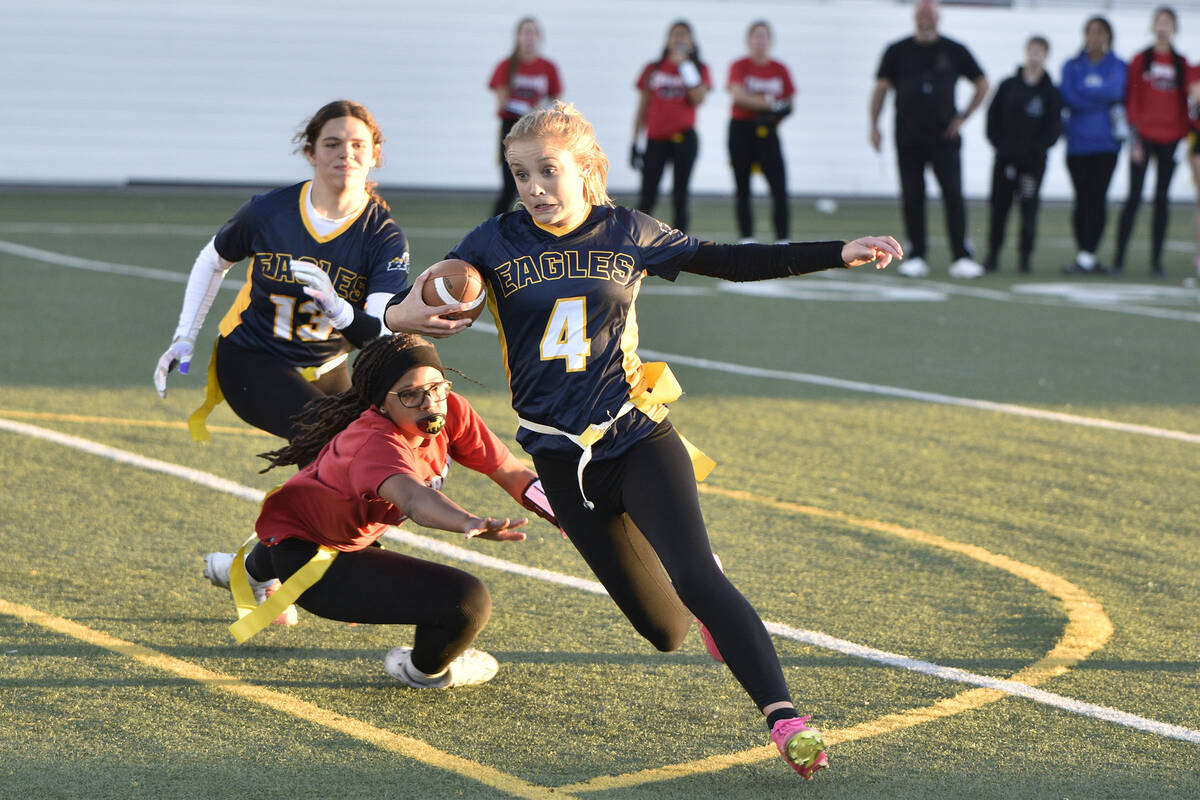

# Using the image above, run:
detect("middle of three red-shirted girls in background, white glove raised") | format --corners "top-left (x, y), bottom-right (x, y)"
top-left (630, 19), bottom-right (713, 231)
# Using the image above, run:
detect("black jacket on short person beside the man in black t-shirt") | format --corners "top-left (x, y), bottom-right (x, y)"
top-left (988, 67), bottom-right (1062, 164)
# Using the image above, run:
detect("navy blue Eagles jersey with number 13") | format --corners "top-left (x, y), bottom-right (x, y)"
top-left (215, 181), bottom-right (408, 367)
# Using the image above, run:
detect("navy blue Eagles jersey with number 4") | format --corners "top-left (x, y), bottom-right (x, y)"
top-left (446, 206), bottom-right (700, 458)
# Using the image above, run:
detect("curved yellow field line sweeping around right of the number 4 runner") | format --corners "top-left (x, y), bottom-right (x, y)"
top-left (558, 483), bottom-right (1112, 793)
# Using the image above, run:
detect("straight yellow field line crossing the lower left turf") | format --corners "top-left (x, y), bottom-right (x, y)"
top-left (0, 599), bottom-right (571, 800)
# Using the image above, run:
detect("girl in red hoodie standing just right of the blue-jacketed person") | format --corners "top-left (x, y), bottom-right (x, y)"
top-left (1112, 6), bottom-right (1190, 278)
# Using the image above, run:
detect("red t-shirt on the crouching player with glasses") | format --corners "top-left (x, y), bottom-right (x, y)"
top-left (254, 392), bottom-right (510, 552)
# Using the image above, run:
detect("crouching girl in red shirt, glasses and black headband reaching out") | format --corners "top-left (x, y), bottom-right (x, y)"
top-left (204, 333), bottom-right (556, 688)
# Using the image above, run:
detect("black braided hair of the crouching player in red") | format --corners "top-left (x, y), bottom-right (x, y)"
top-left (258, 333), bottom-right (430, 473)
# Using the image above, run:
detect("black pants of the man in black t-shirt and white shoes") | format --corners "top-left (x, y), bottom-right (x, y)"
top-left (896, 139), bottom-right (971, 260)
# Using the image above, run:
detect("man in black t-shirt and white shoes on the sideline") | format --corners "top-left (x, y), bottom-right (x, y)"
top-left (870, 0), bottom-right (988, 278)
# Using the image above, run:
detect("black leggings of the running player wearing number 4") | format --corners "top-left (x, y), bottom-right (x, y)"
top-left (533, 422), bottom-right (791, 709)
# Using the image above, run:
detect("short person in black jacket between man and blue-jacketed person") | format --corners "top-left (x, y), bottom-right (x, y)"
top-left (984, 36), bottom-right (1062, 272)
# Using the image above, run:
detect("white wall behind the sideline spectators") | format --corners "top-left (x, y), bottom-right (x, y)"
top-left (7, 0), bottom-right (1200, 198)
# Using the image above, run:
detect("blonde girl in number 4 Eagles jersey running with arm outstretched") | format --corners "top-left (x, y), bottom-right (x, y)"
top-left (385, 103), bottom-right (902, 777)
